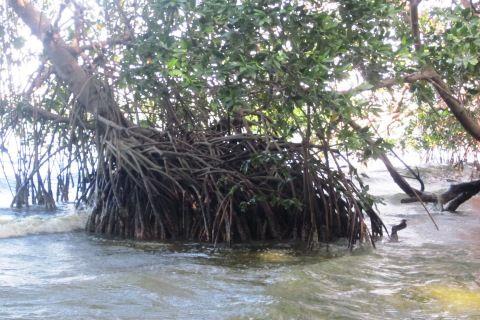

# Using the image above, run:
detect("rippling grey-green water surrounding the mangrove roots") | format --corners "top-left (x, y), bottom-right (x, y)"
top-left (0, 168), bottom-right (480, 319)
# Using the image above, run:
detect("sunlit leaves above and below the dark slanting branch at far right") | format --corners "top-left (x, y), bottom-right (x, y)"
top-left (405, 6), bottom-right (480, 160)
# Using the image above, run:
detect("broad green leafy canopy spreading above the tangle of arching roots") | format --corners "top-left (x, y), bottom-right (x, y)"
top-left (0, 0), bottom-right (480, 164)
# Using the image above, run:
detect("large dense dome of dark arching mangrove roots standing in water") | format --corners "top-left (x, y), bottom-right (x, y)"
top-left (84, 127), bottom-right (383, 246)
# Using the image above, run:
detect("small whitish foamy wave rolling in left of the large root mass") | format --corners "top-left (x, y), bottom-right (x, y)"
top-left (0, 211), bottom-right (89, 238)
